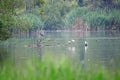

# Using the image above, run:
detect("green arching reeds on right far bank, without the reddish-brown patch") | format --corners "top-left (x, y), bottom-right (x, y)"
top-left (65, 7), bottom-right (120, 29)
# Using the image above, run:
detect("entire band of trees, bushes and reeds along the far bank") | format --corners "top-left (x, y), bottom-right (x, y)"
top-left (0, 0), bottom-right (120, 40)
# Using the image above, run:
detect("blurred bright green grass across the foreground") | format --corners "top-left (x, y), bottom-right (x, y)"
top-left (0, 57), bottom-right (120, 80)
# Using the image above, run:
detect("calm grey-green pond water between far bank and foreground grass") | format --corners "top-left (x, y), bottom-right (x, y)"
top-left (0, 31), bottom-right (120, 69)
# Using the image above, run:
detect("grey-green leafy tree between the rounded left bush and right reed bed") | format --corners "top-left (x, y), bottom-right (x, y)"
top-left (40, 0), bottom-right (76, 30)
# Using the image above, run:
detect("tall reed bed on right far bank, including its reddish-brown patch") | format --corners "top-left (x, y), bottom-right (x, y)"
top-left (66, 7), bottom-right (120, 31)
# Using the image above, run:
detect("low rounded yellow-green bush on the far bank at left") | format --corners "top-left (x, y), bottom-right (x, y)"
top-left (14, 13), bottom-right (43, 29)
